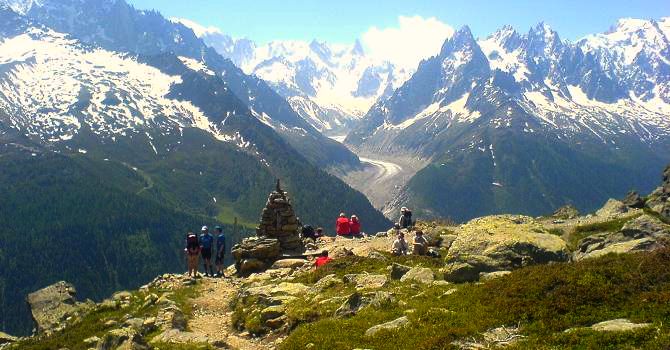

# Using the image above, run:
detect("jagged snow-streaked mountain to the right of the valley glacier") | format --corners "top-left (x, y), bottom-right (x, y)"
top-left (345, 23), bottom-right (670, 220)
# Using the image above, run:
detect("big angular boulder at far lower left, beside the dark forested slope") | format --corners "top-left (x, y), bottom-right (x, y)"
top-left (27, 281), bottom-right (93, 335)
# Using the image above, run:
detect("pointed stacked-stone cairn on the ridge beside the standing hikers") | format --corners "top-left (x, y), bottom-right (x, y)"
top-left (232, 180), bottom-right (304, 275)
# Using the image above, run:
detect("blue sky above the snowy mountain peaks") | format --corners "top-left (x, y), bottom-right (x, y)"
top-left (129, 0), bottom-right (670, 43)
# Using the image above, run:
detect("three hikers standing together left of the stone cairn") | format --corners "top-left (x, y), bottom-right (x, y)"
top-left (184, 226), bottom-right (226, 277)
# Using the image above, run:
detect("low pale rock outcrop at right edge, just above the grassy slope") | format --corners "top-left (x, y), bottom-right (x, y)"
top-left (574, 214), bottom-right (670, 260)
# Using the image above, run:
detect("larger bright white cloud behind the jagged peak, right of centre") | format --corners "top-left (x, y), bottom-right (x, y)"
top-left (362, 16), bottom-right (454, 70)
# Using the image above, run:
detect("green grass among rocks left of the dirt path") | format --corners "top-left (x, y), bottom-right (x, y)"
top-left (12, 286), bottom-right (201, 350)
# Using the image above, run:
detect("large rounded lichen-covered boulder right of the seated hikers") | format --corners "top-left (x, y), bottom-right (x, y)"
top-left (443, 215), bottom-right (569, 282)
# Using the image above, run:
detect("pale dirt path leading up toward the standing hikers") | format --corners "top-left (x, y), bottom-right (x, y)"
top-left (188, 278), bottom-right (275, 350)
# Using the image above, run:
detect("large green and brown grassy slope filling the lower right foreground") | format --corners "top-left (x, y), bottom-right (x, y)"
top-left (281, 248), bottom-right (670, 350)
